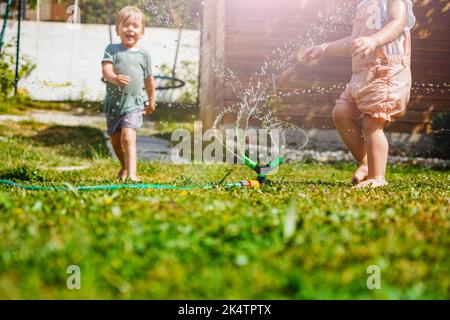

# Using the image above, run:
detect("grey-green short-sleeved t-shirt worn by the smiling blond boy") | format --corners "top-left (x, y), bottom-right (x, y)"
top-left (102, 44), bottom-right (152, 115)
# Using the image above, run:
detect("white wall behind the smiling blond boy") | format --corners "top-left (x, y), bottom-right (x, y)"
top-left (0, 20), bottom-right (200, 101)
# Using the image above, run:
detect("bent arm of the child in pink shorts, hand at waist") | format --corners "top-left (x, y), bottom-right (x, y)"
top-left (351, 0), bottom-right (406, 58)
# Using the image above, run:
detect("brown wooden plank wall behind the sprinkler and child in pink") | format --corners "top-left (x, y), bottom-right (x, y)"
top-left (200, 0), bottom-right (450, 132)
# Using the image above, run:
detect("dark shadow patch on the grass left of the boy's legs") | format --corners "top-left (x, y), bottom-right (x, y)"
top-left (27, 125), bottom-right (109, 159)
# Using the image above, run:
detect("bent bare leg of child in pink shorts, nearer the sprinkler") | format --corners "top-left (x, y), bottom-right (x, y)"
top-left (333, 104), bottom-right (369, 184)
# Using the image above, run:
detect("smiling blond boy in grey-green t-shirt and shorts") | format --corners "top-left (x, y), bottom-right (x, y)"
top-left (102, 6), bottom-right (155, 182)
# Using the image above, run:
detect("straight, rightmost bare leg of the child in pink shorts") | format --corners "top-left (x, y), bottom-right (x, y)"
top-left (356, 116), bottom-right (389, 188)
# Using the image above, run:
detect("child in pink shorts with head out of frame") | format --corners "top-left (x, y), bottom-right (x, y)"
top-left (303, 0), bottom-right (416, 188)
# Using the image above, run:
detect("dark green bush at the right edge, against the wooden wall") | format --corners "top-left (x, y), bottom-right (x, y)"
top-left (432, 112), bottom-right (450, 159)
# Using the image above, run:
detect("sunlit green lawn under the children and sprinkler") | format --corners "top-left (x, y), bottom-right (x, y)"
top-left (0, 121), bottom-right (450, 299)
